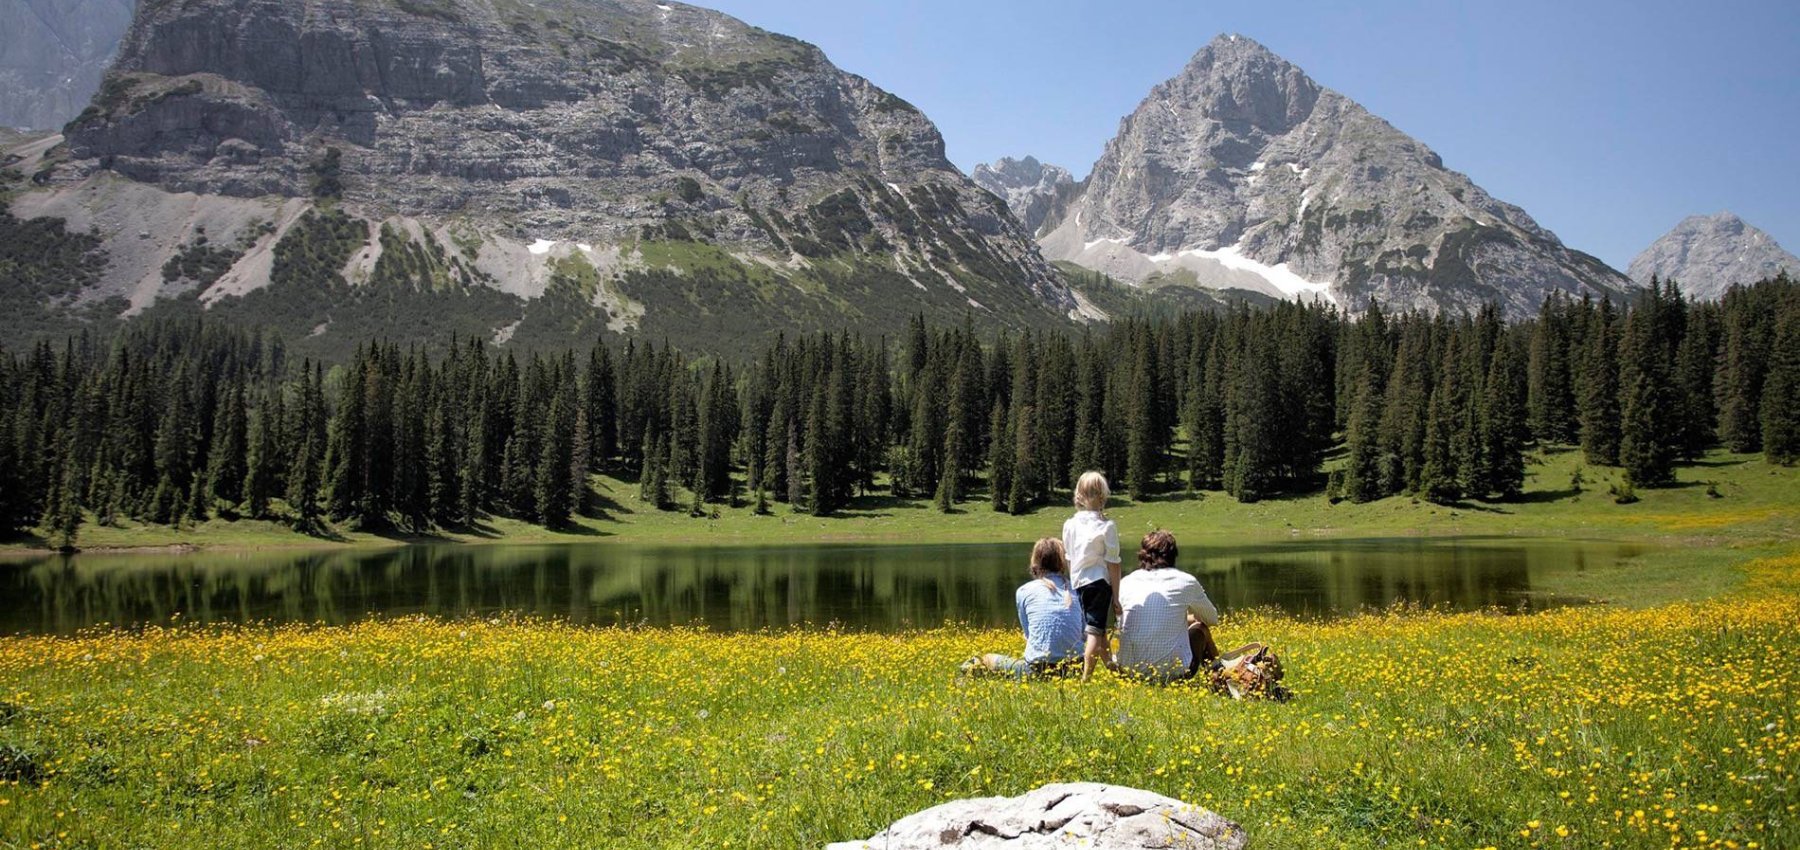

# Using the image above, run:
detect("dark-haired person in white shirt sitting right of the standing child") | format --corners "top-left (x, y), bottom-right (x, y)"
top-left (1118, 531), bottom-right (1219, 683)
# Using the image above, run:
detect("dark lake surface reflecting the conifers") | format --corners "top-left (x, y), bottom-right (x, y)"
top-left (0, 538), bottom-right (1642, 634)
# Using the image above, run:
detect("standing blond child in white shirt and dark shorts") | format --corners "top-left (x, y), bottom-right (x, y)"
top-left (1062, 472), bottom-right (1120, 681)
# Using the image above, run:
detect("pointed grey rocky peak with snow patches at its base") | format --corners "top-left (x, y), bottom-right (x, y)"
top-left (1040, 36), bottom-right (1631, 315)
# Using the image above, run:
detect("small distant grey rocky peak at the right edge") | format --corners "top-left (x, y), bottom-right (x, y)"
top-left (1627, 213), bottom-right (1800, 299)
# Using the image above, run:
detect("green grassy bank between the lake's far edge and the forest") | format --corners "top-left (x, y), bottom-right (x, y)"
top-left (0, 448), bottom-right (1800, 605)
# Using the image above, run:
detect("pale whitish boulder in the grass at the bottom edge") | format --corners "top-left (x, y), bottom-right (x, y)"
top-left (826, 782), bottom-right (1249, 850)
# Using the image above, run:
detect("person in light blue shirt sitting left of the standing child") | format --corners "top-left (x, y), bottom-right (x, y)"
top-left (963, 537), bottom-right (1082, 679)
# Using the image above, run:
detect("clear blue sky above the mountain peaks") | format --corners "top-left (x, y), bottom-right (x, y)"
top-left (698, 0), bottom-right (1800, 268)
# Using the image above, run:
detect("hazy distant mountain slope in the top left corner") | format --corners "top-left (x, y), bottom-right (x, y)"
top-left (0, 0), bottom-right (133, 130)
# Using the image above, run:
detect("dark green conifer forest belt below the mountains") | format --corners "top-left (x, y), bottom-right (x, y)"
top-left (0, 277), bottom-right (1800, 546)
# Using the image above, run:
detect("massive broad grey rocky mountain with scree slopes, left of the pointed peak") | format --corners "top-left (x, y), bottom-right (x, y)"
top-left (9, 0), bottom-right (1080, 348)
